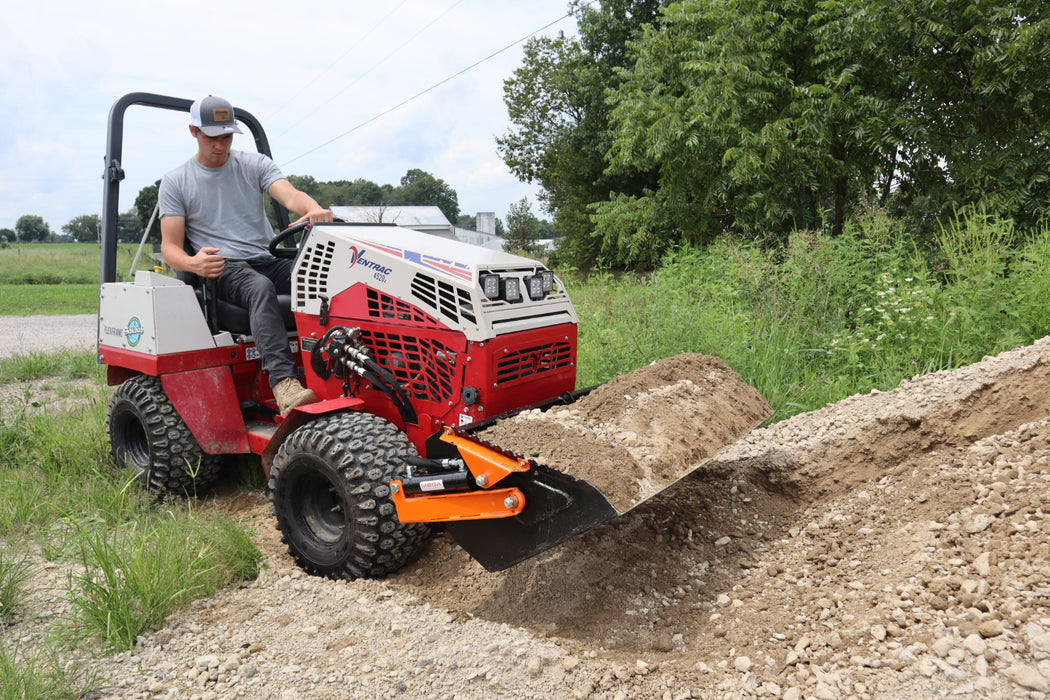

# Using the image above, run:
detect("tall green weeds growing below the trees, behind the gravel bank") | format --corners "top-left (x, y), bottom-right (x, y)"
top-left (573, 206), bottom-right (1050, 421)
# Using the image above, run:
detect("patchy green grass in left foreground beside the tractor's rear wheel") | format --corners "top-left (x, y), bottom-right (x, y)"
top-left (0, 369), bottom-right (261, 700)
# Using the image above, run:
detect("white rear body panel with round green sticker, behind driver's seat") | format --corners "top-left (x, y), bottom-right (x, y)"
top-left (99, 273), bottom-right (215, 355)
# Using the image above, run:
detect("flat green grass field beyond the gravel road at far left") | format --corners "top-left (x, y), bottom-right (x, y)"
top-left (0, 243), bottom-right (161, 316)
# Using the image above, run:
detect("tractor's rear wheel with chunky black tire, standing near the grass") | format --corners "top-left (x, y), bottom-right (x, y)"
top-left (106, 375), bottom-right (222, 496)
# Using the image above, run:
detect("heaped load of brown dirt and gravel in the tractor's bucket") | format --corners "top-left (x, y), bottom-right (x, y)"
top-left (481, 354), bottom-right (772, 512)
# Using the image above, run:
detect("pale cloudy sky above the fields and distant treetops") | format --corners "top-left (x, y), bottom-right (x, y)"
top-left (0, 0), bottom-right (576, 233)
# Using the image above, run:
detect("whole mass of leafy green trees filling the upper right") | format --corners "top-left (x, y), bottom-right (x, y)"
top-left (498, 0), bottom-right (1050, 267)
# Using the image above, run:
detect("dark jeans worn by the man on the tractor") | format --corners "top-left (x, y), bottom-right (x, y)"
top-left (218, 257), bottom-right (296, 387)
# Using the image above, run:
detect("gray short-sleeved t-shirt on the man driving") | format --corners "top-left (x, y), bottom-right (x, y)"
top-left (158, 151), bottom-right (284, 260)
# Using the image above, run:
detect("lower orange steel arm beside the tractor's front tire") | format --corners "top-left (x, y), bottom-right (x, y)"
top-left (391, 481), bottom-right (525, 523)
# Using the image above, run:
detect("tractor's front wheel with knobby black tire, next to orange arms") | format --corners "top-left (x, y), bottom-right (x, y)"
top-left (270, 412), bottom-right (429, 579)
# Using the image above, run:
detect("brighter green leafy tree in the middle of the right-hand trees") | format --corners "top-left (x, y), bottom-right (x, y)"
top-left (596, 0), bottom-right (879, 264)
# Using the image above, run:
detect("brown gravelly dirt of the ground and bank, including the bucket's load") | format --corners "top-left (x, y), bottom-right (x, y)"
top-left (6, 339), bottom-right (1050, 700)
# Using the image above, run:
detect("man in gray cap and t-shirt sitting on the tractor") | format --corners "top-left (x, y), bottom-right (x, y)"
top-left (159, 96), bottom-right (332, 413)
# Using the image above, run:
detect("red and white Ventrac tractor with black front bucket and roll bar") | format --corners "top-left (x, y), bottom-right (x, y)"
top-left (99, 92), bottom-right (638, 578)
